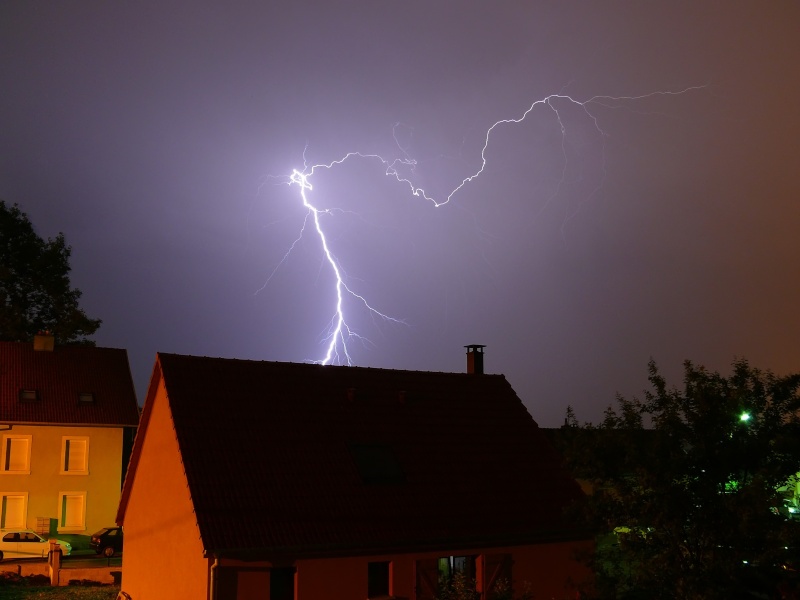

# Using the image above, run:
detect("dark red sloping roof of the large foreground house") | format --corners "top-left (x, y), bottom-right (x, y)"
top-left (118, 354), bottom-right (581, 556)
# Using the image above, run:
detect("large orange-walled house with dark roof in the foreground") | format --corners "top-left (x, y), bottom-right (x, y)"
top-left (118, 347), bottom-right (593, 600)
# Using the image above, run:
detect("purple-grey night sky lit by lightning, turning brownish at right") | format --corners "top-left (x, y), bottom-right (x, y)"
top-left (0, 0), bottom-right (800, 426)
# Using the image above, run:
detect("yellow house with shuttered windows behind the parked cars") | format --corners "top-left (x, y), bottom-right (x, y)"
top-left (0, 335), bottom-right (139, 534)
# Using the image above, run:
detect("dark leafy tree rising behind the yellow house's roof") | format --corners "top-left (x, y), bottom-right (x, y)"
top-left (0, 200), bottom-right (101, 344)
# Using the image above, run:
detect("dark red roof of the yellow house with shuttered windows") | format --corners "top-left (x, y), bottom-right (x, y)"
top-left (0, 342), bottom-right (139, 427)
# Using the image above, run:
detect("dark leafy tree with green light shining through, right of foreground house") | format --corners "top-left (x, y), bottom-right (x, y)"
top-left (562, 360), bottom-right (800, 599)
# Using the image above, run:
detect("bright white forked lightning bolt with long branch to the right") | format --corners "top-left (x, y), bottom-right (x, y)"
top-left (261, 84), bottom-right (708, 365)
